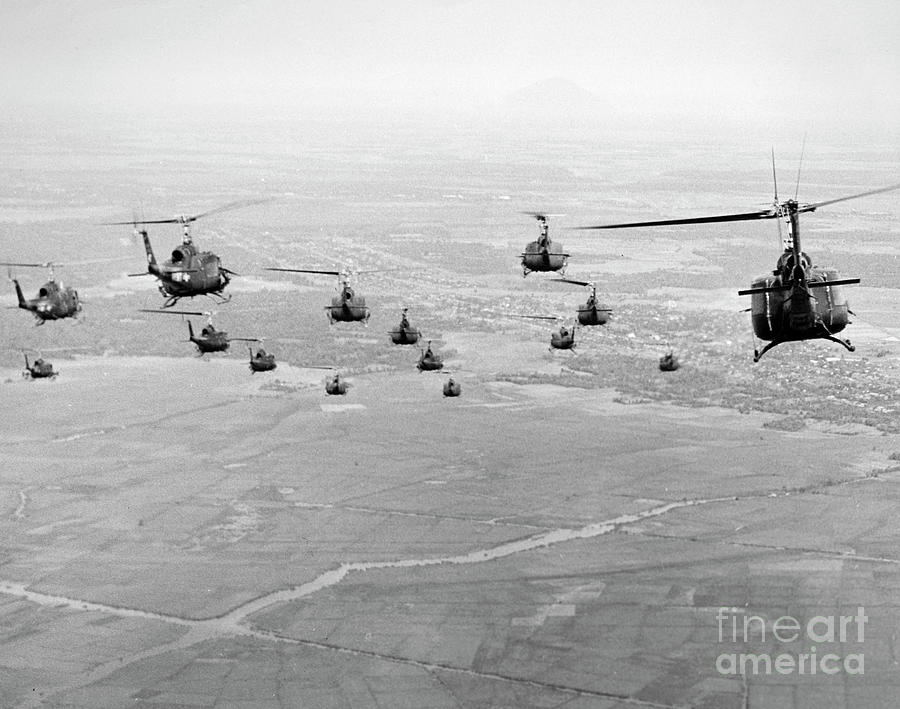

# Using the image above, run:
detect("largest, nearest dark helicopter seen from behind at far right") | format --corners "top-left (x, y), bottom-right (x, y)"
top-left (578, 158), bottom-right (900, 362)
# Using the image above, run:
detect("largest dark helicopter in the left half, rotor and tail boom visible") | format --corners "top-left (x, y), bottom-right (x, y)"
top-left (107, 199), bottom-right (268, 308)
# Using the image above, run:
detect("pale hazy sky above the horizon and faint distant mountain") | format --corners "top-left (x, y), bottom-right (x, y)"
top-left (0, 0), bottom-right (900, 124)
